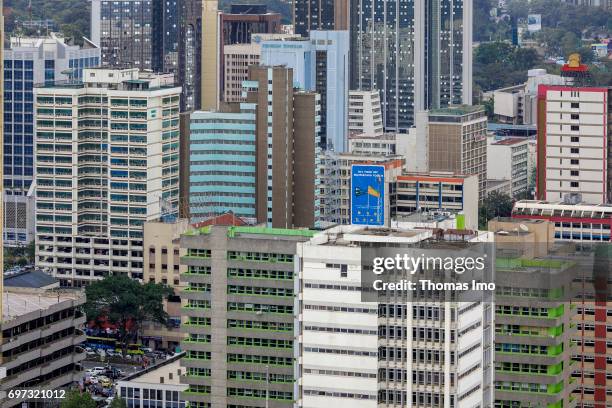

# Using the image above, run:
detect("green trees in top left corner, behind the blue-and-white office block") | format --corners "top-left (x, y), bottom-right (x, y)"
top-left (4, 0), bottom-right (91, 43)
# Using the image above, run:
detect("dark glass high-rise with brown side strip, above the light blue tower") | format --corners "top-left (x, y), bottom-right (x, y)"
top-left (293, 0), bottom-right (349, 37)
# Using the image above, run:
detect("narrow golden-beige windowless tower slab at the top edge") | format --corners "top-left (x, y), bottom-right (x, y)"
top-left (201, 0), bottom-right (222, 111)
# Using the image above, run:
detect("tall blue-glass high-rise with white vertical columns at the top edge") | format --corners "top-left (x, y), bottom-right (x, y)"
top-left (349, 0), bottom-right (473, 131)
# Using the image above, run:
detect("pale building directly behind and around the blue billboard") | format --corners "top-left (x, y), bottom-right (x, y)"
top-left (320, 151), bottom-right (405, 225)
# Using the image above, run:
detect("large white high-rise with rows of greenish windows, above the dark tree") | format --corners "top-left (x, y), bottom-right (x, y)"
top-left (34, 68), bottom-right (181, 286)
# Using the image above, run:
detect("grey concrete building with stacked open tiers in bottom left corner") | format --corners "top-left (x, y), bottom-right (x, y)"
top-left (0, 288), bottom-right (85, 408)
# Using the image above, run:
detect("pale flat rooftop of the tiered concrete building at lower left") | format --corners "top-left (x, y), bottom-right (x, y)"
top-left (2, 288), bottom-right (83, 321)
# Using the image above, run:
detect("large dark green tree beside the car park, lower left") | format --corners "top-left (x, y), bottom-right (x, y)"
top-left (84, 275), bottom-right (173, 356)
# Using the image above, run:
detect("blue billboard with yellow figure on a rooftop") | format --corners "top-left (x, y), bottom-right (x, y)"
top-left (351, 164), bottom-right (385, 226)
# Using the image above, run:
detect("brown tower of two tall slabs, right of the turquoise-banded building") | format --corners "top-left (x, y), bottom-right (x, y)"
top-left (244, 66), bottom-right (321, 228)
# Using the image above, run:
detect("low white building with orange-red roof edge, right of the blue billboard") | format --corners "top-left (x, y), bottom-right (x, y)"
top-left (391, 172), bottom-right (478, 230)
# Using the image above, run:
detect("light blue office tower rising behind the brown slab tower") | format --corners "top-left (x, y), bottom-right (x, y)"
top-left (261, 30), bottom-right (349, 152)
